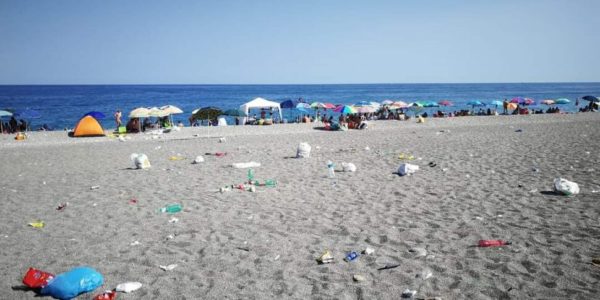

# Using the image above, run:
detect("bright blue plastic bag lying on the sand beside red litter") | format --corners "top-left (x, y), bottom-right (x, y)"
top-left (40, 267), bottom-right (104, 299)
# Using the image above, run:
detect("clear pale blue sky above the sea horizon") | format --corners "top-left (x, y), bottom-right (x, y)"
top-left (0, 0), bottom-right (600, 84)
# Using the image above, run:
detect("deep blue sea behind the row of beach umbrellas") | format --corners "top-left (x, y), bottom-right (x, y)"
top-left (0, 83), bottom-right (600, 130)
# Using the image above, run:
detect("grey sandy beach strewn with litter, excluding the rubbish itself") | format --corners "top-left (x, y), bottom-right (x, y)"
top-left (0, 113), bottom-right (600, 299)
